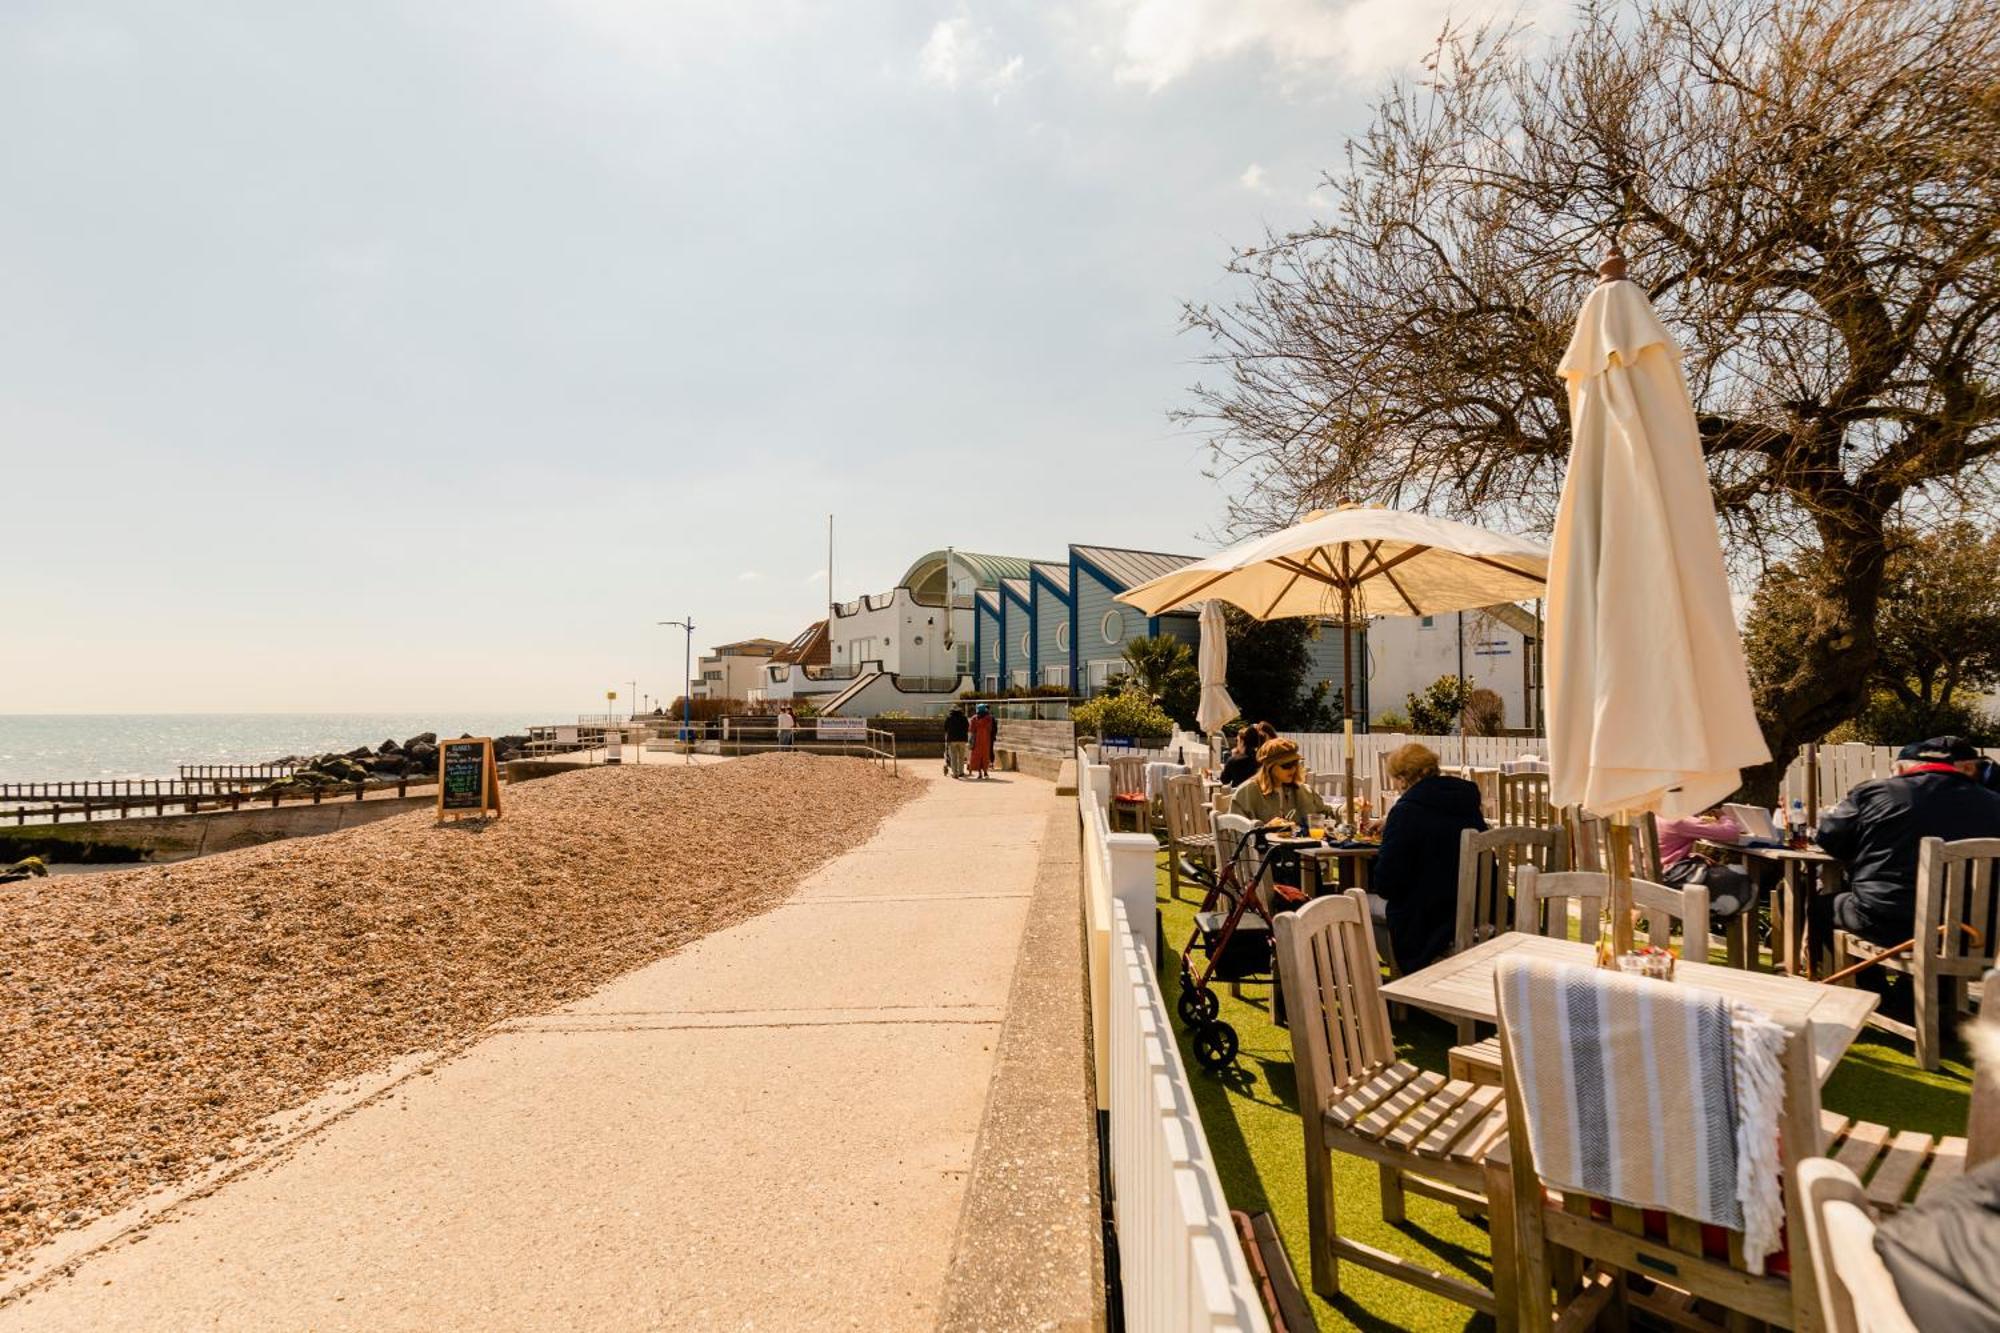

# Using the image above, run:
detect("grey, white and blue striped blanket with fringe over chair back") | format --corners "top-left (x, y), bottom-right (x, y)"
top-left (1494, 959), bottom-right (1786, 1273)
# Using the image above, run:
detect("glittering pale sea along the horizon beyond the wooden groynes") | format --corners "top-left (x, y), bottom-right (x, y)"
top-left (0, 709), bottom-right (556, 783)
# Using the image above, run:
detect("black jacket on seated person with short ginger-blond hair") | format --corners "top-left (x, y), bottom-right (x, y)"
top-left (1374, 775), bottom-right (1486, 973)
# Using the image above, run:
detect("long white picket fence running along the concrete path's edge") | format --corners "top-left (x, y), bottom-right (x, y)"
top-left (1076, 755), bottom-right (1270, 1333)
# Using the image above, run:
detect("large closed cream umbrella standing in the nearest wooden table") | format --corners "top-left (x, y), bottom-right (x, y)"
top-left (1546, 246), bottom-right (1770, 951)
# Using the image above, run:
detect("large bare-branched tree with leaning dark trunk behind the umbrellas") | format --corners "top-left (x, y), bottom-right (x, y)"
top-left (1182, 0), bottom-right (2000, 789)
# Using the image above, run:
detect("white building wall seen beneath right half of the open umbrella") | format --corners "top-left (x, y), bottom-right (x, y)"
top-left (1366, 602), bottom-right (1542, 731)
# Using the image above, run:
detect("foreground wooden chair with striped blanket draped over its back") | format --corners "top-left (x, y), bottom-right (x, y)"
top-left (1496, 979), bottom-right (1822, 1331)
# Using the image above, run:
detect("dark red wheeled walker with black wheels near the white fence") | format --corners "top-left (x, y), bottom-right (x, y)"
top-left (1176, 815), bottom-right (1304, 1073)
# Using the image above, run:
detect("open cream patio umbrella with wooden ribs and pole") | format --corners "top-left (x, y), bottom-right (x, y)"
top-left (1118, 504), bottom-right (1548, 793)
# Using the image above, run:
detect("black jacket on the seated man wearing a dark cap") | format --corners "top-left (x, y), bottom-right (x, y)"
top-left (1820, 773), bottom-right (2000, 943)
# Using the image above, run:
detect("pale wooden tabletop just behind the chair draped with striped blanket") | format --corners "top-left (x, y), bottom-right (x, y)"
top-left (1382, 931), bottom-right (1876, 1085)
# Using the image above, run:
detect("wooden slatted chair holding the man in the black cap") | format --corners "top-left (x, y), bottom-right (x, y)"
top-left (1834, 839), bottom-right (2000, 1071)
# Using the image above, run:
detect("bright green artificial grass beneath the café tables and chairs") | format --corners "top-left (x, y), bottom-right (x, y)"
top-left (1158, 855), bottom-right (1972, 1331)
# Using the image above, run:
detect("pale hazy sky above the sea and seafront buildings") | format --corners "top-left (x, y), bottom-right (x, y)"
top-left (0, 0), bottom-right (1560, 715)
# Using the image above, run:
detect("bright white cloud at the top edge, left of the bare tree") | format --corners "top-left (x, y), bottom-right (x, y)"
top-left (1102, 0), bottom-right (1564, 90)
